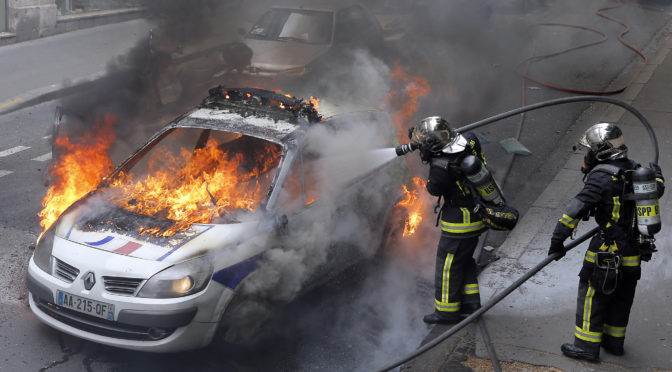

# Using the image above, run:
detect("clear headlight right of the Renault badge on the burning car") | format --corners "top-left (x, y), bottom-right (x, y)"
top-left (138, 256), bottom-right (212, 298)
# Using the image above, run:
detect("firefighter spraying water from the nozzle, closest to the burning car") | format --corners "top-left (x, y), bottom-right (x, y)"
top-left (409, 116), bottom-right (488, 324)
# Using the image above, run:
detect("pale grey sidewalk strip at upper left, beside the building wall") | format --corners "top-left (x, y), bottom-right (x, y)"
top-left (0, 19), bottom-right (151, 115)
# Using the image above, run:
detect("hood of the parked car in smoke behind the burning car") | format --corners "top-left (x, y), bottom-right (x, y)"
top-left (245, 39), bottom-right (331, 72)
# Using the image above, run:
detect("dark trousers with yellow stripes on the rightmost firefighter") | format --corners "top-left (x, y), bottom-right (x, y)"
top-left (574, 278), bottom-right (637, 353)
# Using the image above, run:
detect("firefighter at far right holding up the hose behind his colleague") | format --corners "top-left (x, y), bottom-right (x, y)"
top-left (548, 123), bottom-right (664, 362)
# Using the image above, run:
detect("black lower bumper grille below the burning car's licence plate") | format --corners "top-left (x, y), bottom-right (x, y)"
top-left (37, 298), bottom-right (175, 341)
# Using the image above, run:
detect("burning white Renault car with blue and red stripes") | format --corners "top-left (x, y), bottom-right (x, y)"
top-left (27, 87), bottom-right (406, 352)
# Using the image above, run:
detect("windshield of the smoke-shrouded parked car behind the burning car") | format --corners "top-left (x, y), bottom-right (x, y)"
top-left (247, 9), bottom-right (333, 44)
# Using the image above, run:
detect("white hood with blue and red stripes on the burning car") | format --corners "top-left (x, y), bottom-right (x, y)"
top-left (56, 208), bottom-right (265, 267)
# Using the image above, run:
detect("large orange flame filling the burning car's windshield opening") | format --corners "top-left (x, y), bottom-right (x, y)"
top-left (110, 139), bottom-right (281, 237)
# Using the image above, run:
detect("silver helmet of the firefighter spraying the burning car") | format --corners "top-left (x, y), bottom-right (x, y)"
top-left (411, 116), bottom-right (467, 154)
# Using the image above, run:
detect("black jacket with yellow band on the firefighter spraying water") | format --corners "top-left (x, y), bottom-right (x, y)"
top-left (427, 132), bottom-right (487, 238)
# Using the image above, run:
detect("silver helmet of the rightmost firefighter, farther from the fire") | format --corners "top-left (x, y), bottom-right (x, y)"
top-left (575, 123), bottom-right (628, 161)
